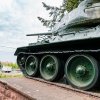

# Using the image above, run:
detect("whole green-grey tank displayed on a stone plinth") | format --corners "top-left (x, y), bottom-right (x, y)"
top-left (14, 0), bottom-right (100, 90)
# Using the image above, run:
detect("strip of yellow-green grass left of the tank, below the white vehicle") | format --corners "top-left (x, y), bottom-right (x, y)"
top-left (0, 72), bottom-right (24, 78)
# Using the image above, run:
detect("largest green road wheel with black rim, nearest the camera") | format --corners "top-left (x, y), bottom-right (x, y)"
top-left (65, 54), bottom-right (99, 90)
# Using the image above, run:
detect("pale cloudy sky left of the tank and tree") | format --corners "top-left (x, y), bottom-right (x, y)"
top-left (0, 0), bottom-right (62, 62)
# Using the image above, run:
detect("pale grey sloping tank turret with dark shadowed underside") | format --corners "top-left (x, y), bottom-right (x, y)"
top-left (53, 0), bottom-right (100, 33)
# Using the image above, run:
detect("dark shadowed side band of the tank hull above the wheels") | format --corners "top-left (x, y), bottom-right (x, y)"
top-left (14, 37), bottom-right (100, 55)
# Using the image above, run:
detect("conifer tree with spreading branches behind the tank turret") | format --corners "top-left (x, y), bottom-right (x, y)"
top-left (38, 0), bottom-right (79, 30)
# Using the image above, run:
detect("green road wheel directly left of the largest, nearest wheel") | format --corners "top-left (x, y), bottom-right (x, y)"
top-left (40, 55), bottom-right (64, 81)
